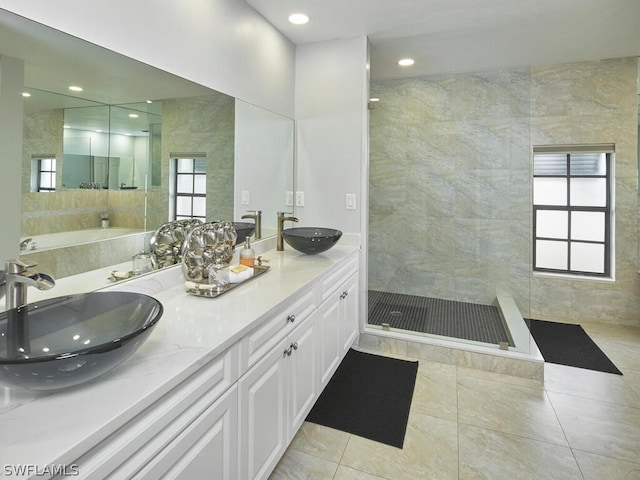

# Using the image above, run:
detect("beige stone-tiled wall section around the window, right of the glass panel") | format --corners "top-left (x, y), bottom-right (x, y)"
top-left (531, 57), bottom-right (640, 325)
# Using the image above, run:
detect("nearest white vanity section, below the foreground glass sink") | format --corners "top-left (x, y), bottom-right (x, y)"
top-left (69, 346), bottom-right (239, 480)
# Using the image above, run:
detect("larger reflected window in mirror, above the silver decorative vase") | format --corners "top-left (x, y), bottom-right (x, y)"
top-left (172, 157), bottom-right (207, 222)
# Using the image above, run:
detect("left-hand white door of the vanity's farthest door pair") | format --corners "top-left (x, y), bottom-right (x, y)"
top-left (318, 292), bottom-right (341, 392)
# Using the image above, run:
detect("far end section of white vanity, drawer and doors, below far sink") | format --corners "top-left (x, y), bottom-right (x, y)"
top-left (319, 256), bottom-right (358, 391)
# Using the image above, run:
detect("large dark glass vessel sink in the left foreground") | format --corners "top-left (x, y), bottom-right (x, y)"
top-left (0, 292), bottom-right (163, 390)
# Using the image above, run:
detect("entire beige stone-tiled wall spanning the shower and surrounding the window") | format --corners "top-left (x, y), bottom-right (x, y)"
top-left (369, 58), bottom-right (640, 325)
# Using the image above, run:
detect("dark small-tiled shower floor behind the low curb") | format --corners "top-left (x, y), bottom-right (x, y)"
top-left (369, 290), bottom-right (514, 346)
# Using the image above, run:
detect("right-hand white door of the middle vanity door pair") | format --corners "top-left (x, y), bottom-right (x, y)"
top-left (287, 313), bottom-right (318, 439)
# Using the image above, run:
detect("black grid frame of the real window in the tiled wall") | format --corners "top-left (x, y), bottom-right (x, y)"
top-left (532, 144), bottom-right (615, 279)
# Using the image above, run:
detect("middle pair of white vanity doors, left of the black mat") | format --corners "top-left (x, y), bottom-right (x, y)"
top-left (238, 298), bottom-right (318, 480)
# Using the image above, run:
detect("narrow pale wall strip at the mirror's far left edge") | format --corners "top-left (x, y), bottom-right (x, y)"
top-left (0, 55), bottom-right (24, 262)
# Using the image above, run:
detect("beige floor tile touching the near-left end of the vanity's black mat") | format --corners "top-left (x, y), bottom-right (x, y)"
top-left (289, 422), bottom-right (350, 463)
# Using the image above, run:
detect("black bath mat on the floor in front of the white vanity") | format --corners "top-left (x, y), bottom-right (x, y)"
top-left (307, 350), bottom-right (418, 448)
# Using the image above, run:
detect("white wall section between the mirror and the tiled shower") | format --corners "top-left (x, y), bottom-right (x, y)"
top-left (295, 37), bottom-right (368, 233)
